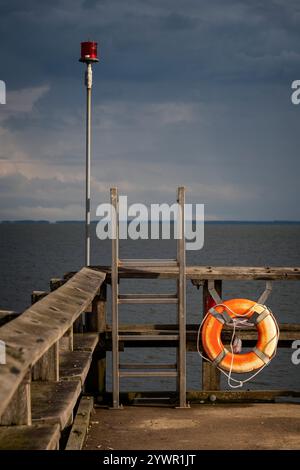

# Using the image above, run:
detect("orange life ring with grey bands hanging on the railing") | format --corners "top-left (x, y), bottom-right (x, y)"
top-left (201, 299), bottom-right (278, 373)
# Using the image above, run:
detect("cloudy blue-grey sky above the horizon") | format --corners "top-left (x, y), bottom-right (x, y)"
top-left (0, 0), bottom-right (300, 221)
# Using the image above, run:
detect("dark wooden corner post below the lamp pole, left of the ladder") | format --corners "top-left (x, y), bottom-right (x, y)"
top-left (86, 284), bottom-right (106, 398)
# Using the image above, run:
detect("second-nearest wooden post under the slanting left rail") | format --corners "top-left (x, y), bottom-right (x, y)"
top-left (32, 341), bottom-right (59, 382)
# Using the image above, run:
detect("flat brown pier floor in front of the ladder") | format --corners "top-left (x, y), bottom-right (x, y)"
top-left (84, 403), bottom-right (300, 450)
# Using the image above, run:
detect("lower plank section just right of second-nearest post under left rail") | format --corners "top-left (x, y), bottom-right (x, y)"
top-left (59, 351), bottom-right (92, 386)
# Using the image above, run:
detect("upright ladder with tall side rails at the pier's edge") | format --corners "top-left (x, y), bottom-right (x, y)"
top-left (110, 187), bottom-right (187, 409)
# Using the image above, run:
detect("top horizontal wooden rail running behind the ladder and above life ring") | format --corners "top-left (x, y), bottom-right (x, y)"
top-left (92, 266), bottom-right (300, 282)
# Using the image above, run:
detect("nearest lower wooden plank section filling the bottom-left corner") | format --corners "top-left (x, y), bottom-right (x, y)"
top-left (0, 424), bottom-right (60, 450)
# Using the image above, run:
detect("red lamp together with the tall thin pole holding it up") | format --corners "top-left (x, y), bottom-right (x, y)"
top-left (79, 41), bottom-right (99, 266)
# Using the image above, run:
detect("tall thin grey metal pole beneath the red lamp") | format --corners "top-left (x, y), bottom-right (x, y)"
top-left (85, 63), bottom-right (93, 266)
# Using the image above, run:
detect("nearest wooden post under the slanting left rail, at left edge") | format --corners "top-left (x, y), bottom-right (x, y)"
top-left (0, 371), bottom-right (32, 426)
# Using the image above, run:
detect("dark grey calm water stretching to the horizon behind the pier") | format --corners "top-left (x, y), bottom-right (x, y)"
top-left (0, 223), bottom-right (300, 390)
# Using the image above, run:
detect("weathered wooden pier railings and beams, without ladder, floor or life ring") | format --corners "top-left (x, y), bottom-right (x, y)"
top-left (0, 266), bottom-right (300, 449)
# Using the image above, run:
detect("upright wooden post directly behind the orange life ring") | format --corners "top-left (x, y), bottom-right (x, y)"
top-left (202, 280), bottom-right (222, 391)
